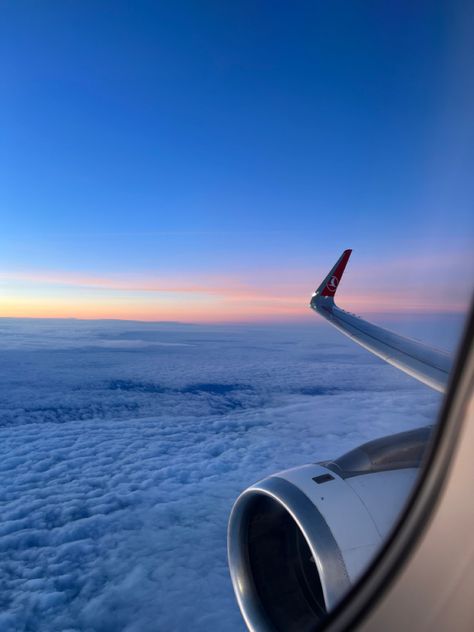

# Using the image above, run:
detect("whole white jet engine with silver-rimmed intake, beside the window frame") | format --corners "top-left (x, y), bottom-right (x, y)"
top-left (228, 428), bottom-right (430, 632)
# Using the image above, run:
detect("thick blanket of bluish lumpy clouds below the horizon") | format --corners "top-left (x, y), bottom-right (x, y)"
top-left (0, 319), bottom-right (448, 632)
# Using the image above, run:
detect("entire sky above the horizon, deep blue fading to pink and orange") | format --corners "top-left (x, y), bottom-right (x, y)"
top-left (0, 0), bottom-right (474, 321)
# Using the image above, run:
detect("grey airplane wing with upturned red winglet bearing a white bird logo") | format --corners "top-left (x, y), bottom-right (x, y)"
top-left (310, 250), bottom-right (452, 392)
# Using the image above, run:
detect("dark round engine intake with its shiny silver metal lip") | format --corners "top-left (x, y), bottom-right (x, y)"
top-left (228, 477), bottom-right (350, 632)
